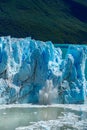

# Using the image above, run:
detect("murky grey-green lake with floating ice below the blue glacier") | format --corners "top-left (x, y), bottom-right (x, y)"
top-left (0, 104), bottom-right (87, 130)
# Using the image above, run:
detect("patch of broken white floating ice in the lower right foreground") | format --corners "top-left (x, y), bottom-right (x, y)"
top-left (16, 112), bottom-right (87, 130)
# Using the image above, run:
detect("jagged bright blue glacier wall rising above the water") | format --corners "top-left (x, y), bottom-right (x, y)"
top-left (0, 36), bottom-right (87, 104)
